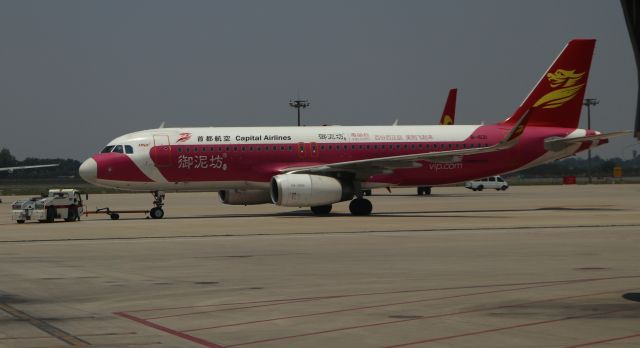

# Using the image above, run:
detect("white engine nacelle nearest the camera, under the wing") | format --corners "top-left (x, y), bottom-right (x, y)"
top-left (271, 174), bottom-right (353, 207)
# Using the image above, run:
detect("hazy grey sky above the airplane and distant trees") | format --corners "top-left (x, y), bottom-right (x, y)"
top-left (0, 0), bottom-right (640, 160)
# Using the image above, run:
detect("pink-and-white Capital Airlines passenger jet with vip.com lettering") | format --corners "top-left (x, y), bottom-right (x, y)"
top-left (79, 39), bottom-right (630, 219)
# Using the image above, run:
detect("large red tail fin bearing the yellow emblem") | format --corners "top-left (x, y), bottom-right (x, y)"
top-left (503, 39), bottom-right (596, 128)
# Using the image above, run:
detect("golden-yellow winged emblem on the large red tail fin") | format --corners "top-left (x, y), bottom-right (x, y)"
top-left (533, 69), bottom-right (584, 109)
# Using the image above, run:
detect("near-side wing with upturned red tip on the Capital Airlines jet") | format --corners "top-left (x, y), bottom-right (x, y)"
top-left (282, 111), bottom-right (531, 179)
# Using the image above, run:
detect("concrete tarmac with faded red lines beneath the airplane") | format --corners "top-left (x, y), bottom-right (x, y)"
top-left (0, 185), bottom-right (640, 347)
